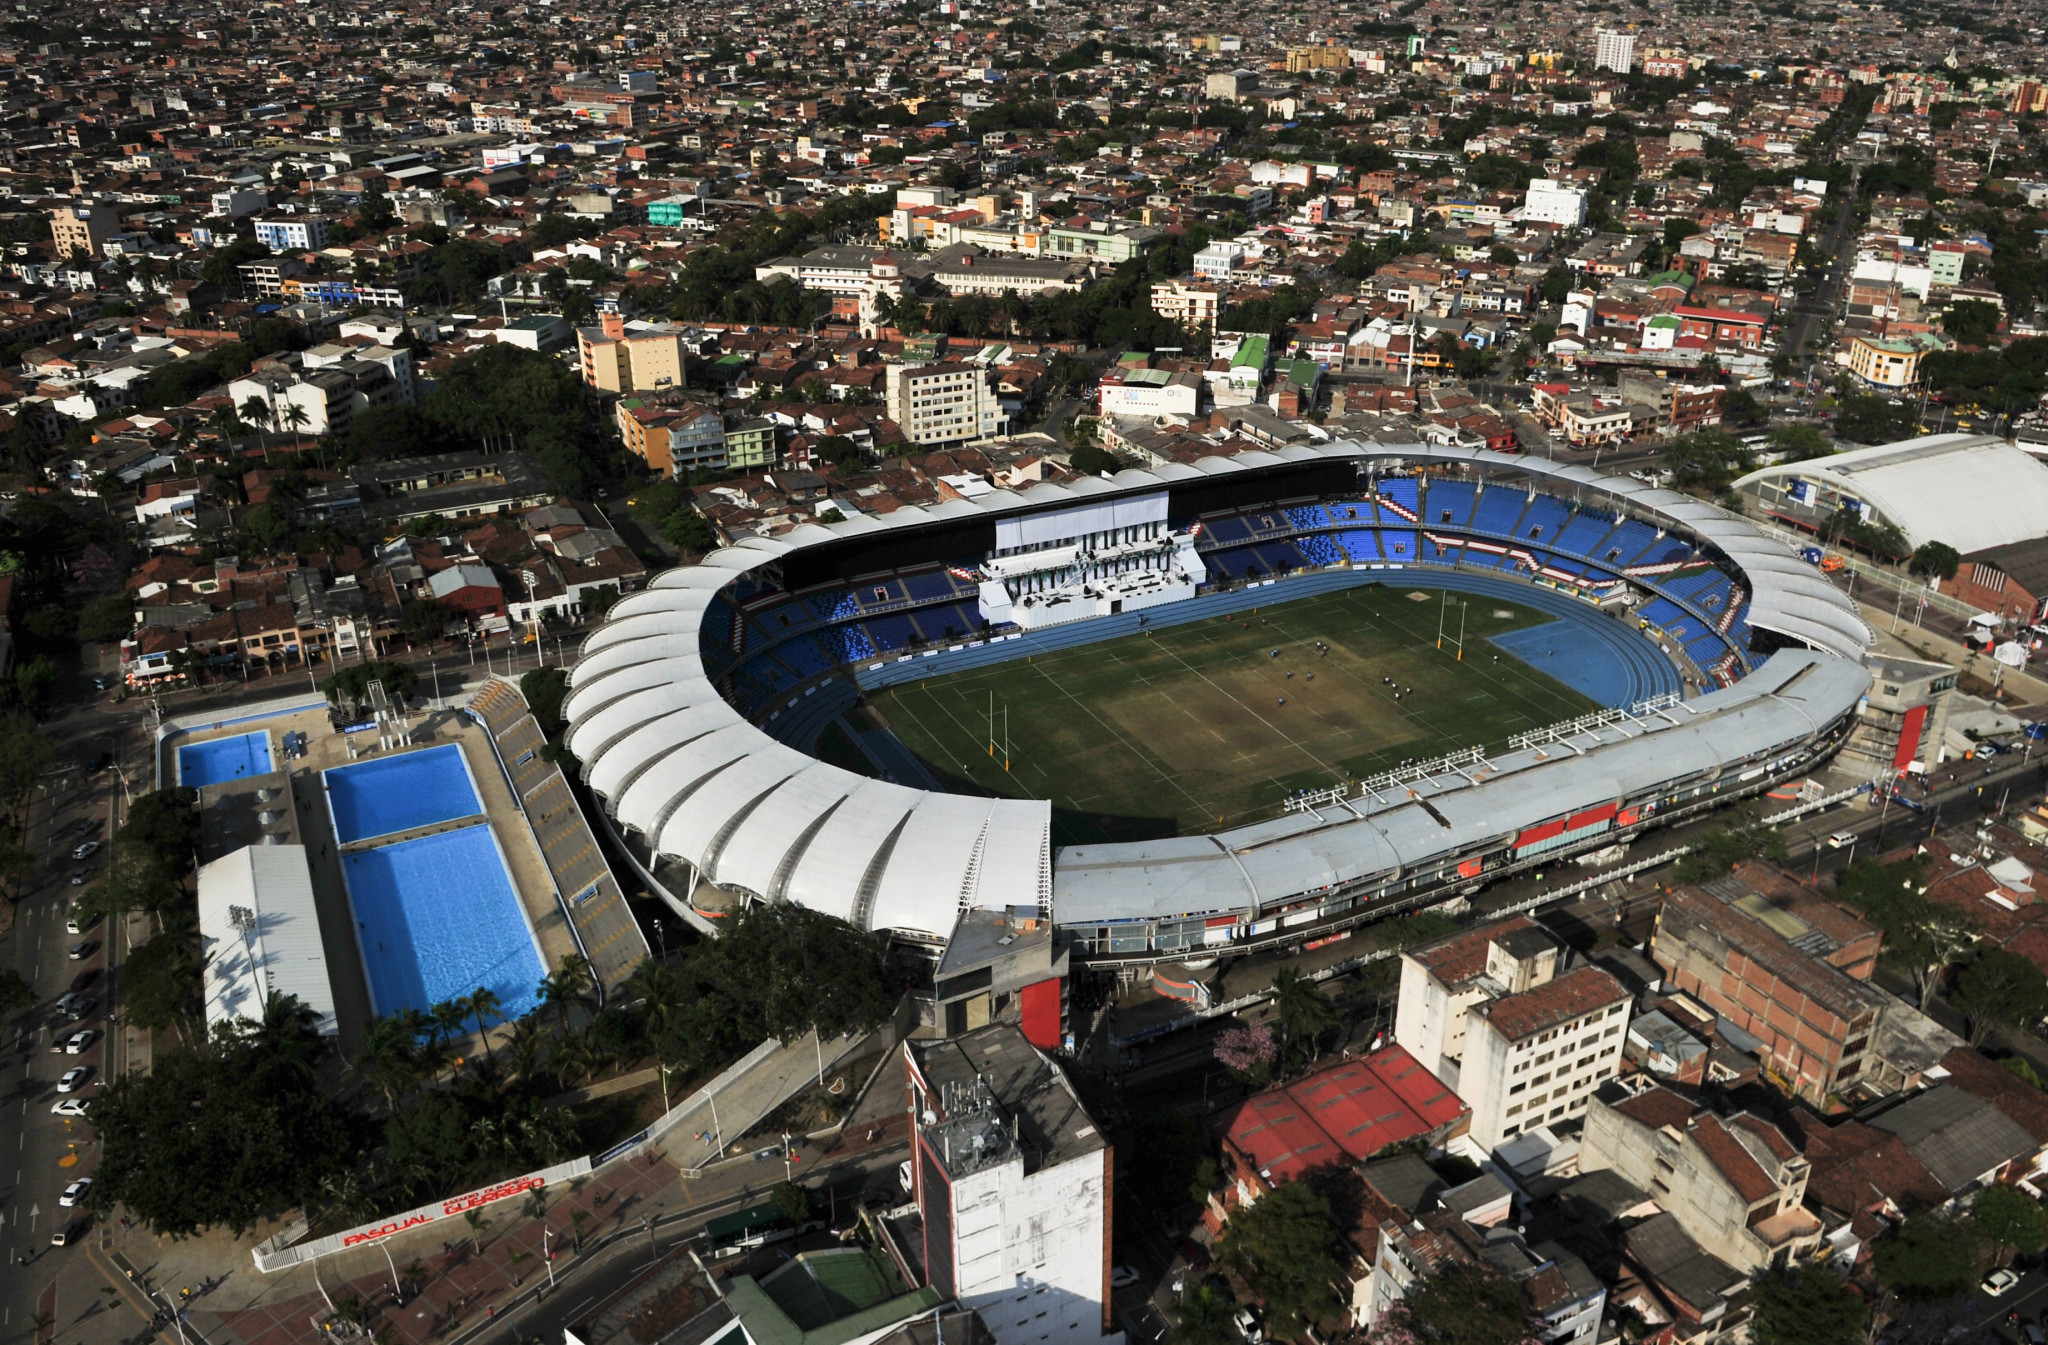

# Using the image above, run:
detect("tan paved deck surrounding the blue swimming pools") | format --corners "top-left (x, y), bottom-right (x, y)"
top-left (172, 710), bottom-right (575, 1056)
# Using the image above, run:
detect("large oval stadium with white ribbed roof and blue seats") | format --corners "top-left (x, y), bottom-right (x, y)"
top-left (565, 442), bottom-right (1872, 966)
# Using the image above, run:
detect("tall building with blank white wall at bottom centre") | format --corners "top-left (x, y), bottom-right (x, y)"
top-left (903, 1024), bottom-right (1114, 1345)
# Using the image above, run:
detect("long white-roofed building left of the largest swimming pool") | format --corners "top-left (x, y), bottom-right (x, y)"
top-left (199, 845), bottom-right (336, 1036)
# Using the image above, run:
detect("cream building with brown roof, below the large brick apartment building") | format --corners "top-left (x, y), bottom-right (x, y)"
top-left (1579, 1075), bottom-right (1821, 1273)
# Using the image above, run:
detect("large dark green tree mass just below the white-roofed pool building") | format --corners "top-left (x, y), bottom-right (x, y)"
top-left (90, 995), bottom-right (360, 1239)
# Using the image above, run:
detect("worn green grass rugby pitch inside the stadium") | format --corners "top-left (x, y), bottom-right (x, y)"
top-left (868, 581), bottom-right (1597, 845)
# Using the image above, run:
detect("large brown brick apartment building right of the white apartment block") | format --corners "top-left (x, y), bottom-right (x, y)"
top-left (1651, 864), bottom-right (1886, 1105)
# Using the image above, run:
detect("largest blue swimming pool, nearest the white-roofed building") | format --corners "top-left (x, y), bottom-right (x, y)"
top-left (342, 825), bottom-right (545, 1017)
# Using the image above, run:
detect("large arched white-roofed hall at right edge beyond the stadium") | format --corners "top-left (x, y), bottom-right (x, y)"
top-left (1735, 434), bottom-right (2048, 555)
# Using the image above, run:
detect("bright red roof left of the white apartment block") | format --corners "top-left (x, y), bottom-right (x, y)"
top-left (1225, 1046), bottom-right (1466, 1185)
